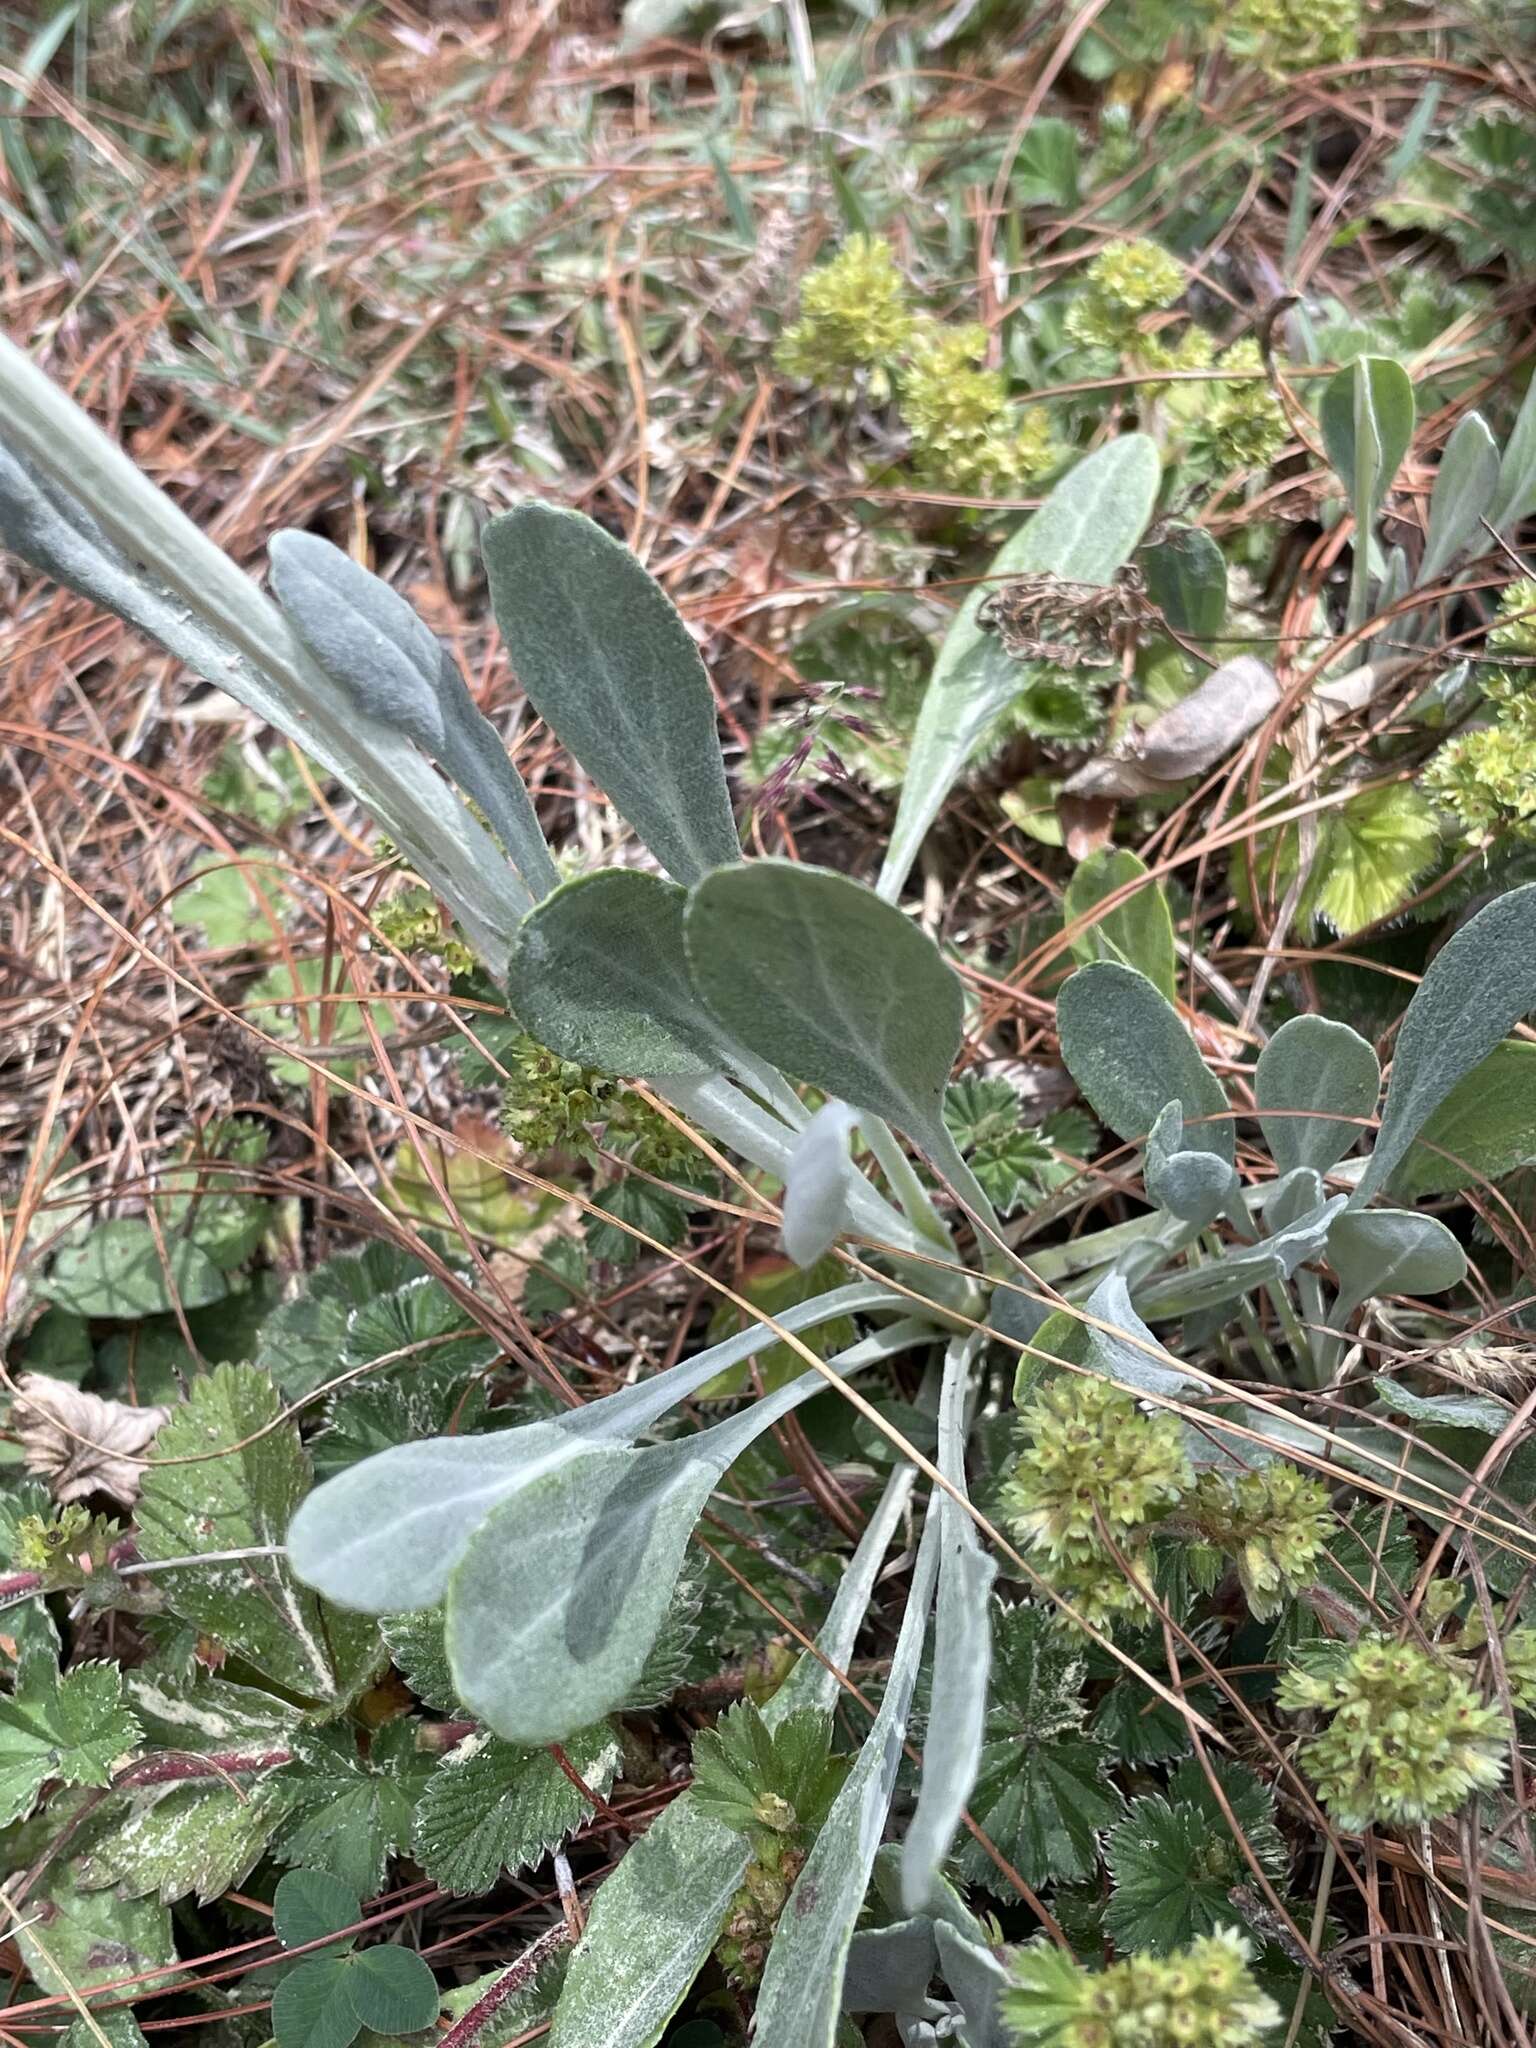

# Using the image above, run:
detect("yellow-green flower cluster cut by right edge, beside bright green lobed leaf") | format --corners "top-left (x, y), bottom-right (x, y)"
top-left (1423, 578), bottom-right (1536, 844)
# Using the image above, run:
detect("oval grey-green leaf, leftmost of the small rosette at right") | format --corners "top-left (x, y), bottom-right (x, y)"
top-left (1057, 961), bottom-right (1235, 1163)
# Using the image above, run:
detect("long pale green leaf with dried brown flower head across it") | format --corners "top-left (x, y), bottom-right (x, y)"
top-left (879, 434), bottom-right (1159, 899)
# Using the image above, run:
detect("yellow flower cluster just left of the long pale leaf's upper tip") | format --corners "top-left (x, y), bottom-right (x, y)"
top-left (901, 322), bottom-right (1057, 494)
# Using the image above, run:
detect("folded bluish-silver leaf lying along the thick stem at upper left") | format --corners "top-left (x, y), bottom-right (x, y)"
top-left (266, 528), bottom-right (559, 897)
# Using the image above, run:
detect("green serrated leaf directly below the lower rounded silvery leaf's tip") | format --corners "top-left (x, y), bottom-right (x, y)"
top-left (412, 1722), bottom-right (618, 1894)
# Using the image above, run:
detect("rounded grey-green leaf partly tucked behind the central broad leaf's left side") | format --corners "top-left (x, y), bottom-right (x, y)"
top-left (506, 868), bottom-right (725, 1079)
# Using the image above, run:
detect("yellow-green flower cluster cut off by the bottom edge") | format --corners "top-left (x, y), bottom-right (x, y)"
top-left (1004, 1927), bottom-right (1282, 2048)
